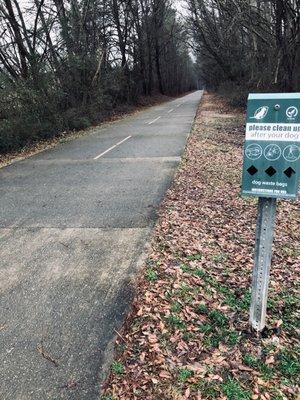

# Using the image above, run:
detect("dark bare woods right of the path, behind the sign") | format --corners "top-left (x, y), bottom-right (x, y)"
top-left (187, 0), bottom-right (300, 105)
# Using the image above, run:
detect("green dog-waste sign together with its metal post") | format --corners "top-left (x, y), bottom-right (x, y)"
top-left (242, 93), bottom-right (300, 331)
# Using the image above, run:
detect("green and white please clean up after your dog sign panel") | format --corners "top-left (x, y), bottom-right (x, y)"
top-left (242, 93), bottom-right (300, 199)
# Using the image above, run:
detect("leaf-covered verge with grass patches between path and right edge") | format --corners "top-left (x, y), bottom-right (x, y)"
top-left (102, 94), bottom-right (300, 400)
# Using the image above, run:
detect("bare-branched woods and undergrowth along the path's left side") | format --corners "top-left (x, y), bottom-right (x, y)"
top-left (0, 0), bottom-right (196, 152)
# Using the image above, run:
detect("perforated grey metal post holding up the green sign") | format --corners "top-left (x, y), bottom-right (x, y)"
top-left (250, 197), bottom-right (276, 331)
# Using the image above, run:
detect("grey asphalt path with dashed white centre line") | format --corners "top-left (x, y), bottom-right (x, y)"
top-left (0, 91), bottom-right (202, 400)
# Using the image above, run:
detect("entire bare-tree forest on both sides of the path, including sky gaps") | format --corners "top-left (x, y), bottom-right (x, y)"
top-left (0, 0), bottom-right (300, 153)
